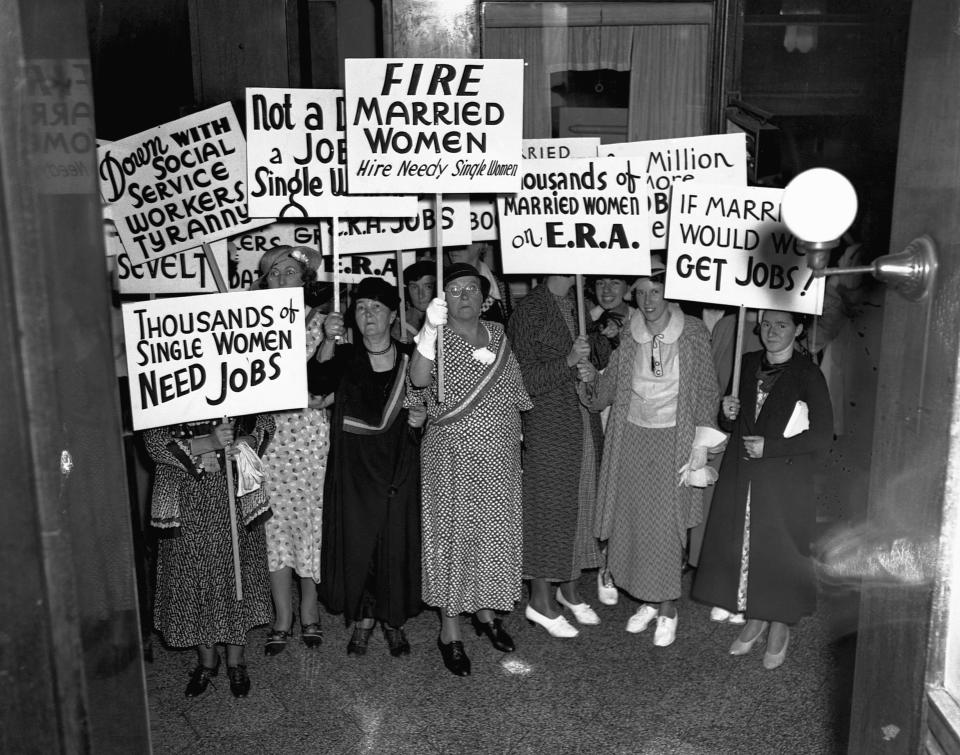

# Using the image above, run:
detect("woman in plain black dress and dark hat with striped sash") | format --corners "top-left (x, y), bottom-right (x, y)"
top-left (307, 278), bottom-right (426, 657)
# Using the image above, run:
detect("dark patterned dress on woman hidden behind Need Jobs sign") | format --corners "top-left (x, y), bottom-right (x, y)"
top-left (143, 415), bottom-right (273, 648)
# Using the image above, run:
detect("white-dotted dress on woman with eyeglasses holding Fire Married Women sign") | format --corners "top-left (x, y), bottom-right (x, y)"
top-left (406, 322), bottom-right (533, 616)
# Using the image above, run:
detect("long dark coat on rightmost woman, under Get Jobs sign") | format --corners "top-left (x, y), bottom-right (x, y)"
top-left (692, 351), bottom-right (833, 624)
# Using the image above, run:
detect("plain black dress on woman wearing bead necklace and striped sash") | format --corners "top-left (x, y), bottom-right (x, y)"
top-left (307, 341), bottom-right (421, 626)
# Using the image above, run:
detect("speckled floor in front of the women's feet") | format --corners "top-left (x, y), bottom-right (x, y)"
top-left (147, 575), bottom-right (853, 755)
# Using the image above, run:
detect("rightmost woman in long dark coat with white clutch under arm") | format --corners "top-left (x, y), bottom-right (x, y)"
top-left (693, 311), bottom-right (833, 669)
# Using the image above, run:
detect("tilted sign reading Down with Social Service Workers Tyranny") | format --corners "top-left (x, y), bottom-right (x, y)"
top-left (97, 103), bottom-right (266, 265)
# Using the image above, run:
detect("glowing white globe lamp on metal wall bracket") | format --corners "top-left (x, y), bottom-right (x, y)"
top-left (780, 168), bottom-right (937, 301)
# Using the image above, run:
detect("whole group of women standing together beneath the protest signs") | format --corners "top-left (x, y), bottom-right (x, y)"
top-left (145, 246), bottom-right (832, 697)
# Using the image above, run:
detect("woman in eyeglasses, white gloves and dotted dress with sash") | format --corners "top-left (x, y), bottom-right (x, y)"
top-left (407, 263), bottom-right (533, 676)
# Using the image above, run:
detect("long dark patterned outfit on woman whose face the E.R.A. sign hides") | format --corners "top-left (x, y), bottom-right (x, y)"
top-left (508, 285), bottom-right (610, 582)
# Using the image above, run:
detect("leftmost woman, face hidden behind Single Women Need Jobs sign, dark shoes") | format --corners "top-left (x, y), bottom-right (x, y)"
top-left (143, 415), bottom-right (274, 697)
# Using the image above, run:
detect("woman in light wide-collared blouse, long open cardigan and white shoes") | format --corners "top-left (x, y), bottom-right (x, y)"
top-left (582, 259), bottom-right (719, 647)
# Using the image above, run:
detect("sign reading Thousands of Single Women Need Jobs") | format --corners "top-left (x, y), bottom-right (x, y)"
top-left (123, 288), bottom-right (307, 430)
